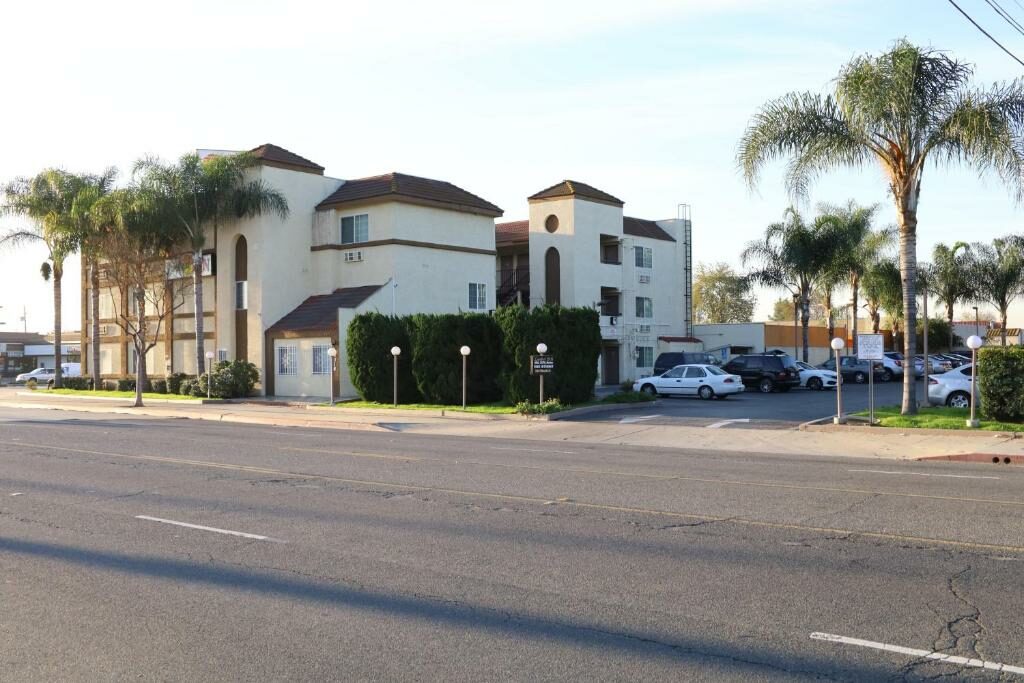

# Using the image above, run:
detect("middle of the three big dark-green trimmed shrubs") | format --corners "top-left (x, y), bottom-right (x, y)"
top-left (408, 313), bottom-right (502, 405)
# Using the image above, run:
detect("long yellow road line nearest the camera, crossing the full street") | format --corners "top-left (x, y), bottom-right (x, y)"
top-left (6, 441), bottom-right (1024, 554)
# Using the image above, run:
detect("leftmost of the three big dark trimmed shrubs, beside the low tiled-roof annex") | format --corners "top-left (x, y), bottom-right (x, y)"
top-left (345, 313), bottom-right (420, 403)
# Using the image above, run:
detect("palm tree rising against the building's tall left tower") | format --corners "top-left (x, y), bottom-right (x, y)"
top-left (135, 153), bottom-right (289, 375)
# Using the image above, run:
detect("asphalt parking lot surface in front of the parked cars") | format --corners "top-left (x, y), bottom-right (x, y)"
top-left (580, 380), bottom-right (925, 429)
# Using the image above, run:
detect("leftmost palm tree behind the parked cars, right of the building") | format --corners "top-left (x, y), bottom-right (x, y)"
top-left (740, 207), bottom-right (839, 362)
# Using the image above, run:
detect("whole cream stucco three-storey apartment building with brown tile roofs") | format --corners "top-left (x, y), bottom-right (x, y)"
top-left (82, 144), bottom-right (690, 396)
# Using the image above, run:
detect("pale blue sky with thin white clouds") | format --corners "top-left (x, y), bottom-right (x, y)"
top-left (0, 0), bottom-right (1024, 332)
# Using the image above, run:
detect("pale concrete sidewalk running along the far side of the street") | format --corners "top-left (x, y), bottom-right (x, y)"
top-left (0, 391), bottom-right (1024, 460)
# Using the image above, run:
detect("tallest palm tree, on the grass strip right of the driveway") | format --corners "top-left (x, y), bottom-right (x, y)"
top-left (737, 40), bottom-right (1024, 415)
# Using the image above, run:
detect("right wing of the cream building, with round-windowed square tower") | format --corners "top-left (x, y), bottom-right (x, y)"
top-left (495, 180), bottom-right (699, 384)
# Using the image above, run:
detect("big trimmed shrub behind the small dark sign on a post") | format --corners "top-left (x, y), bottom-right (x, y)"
top-left (495, 305), bottom-right (601, 404)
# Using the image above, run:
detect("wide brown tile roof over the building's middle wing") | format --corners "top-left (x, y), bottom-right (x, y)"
top-left (316, 173), bottom-right (503, 216)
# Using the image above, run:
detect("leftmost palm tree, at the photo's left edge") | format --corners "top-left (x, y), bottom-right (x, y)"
top-left (0, 168), bottom-right (82, 388)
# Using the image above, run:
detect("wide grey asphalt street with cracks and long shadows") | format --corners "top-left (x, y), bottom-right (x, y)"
top-left (0, 410), bottom-right (1024, 681)
